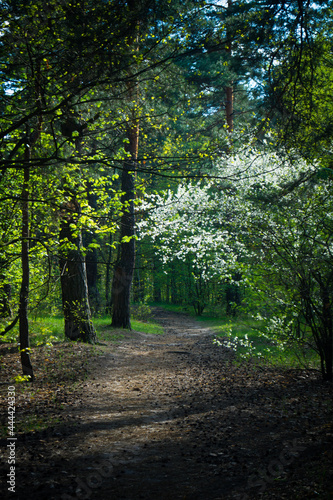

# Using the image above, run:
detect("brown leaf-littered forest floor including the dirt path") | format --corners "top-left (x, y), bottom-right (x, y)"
top-left (0, 308), bottom-right (333, 500)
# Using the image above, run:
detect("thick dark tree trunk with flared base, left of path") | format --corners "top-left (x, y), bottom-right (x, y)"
top-left (59, 200), bottom-right (96, 343)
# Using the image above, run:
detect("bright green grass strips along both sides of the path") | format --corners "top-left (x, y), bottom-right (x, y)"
top-left (2, 304), bottom-right (320, 369)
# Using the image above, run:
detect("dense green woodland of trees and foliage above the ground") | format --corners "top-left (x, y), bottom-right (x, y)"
top-left (0, 0), bottom-right (333, 380)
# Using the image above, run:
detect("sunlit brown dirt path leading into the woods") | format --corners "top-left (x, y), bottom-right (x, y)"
top-left (65, 309), bottom-right (235, 500)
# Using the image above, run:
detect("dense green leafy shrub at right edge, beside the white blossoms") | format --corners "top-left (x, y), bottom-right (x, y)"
top-left (241, 166), bottom-right (333, 380)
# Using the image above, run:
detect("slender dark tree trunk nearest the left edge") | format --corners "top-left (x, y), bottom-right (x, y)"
top-left (19, 146), bottom-right (34, 381)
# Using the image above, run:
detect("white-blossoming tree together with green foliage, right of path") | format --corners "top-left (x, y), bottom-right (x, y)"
top-left (139, 146), bottom-right (333, 380)
